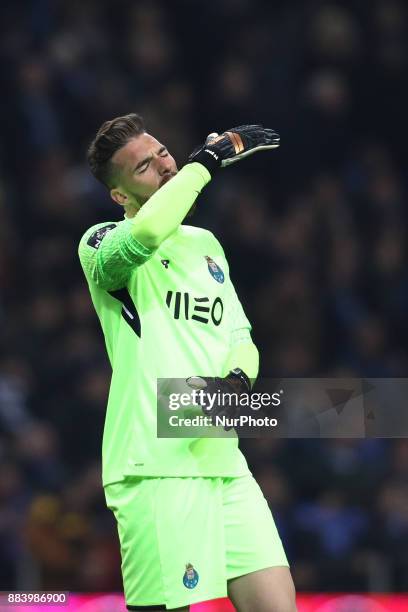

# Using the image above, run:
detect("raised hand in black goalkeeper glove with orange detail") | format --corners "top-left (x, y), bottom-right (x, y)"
top-left (188, 125), bottom-right (280, 174)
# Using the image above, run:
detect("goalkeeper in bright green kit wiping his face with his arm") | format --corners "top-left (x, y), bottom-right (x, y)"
top-left (79, 114), bottom-right (296, 612)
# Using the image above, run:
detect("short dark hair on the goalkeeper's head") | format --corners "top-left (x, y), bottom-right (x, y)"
top-left (87, 113), bottom-right (146, 189)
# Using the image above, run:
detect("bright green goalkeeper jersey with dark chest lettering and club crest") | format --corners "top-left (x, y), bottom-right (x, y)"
top-left (79, 165), bottom-right (251, 486)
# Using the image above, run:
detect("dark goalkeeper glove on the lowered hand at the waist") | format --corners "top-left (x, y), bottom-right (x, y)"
top-left (186, 368), bottom-right (251, 431)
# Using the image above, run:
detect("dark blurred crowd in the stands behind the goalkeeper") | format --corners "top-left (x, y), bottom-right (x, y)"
top-left (0, 0), bottom-right (408, 591)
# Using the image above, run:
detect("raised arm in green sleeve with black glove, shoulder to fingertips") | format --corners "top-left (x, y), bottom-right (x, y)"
top-left (79, 125), bottom-right (279, 291)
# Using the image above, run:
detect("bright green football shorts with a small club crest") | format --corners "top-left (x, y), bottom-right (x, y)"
top-left (105, 473), bottom-right (288, 610)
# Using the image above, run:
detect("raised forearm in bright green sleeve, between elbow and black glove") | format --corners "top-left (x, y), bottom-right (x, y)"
top-left (132, 163), bottom-right (211, 249)
